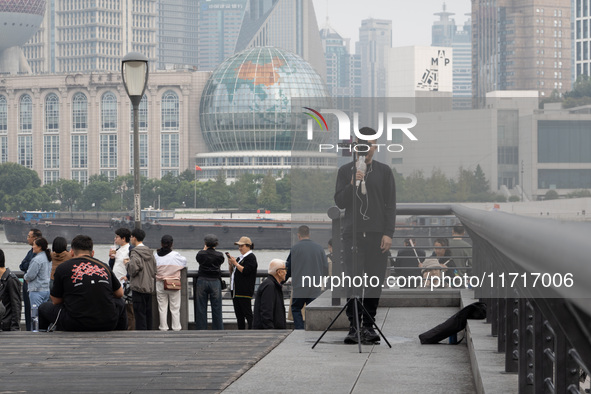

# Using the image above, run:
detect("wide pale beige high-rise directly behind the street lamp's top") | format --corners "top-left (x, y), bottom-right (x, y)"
top-left (23, 0), bottom-right (157, 73)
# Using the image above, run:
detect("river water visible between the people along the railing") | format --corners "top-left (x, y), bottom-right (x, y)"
top-left (0, 229), bottom-right (289, 271)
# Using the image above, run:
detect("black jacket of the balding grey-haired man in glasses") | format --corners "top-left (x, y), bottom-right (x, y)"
top-left (252, 275), bottom-right (286, 330)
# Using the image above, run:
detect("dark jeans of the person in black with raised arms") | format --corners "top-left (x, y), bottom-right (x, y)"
top-left (195, 278), bottom-right (224, 330)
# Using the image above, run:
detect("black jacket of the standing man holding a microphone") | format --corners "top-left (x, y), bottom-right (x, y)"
top-left (334, 160), bottom-right (396, 237)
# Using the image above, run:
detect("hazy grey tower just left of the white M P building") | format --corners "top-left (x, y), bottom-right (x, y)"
top-left (356, 19), bottom-right (392, 97)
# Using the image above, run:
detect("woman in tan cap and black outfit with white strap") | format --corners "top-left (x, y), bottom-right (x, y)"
top-left (226, 237), bottom-right (258, 330)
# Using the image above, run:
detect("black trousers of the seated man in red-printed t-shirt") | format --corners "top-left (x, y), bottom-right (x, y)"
top-left (39, 298), bottom-right (127, 331)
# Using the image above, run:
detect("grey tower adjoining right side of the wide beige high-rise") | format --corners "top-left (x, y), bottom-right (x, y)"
top-left (157, 0), bottom-right (199, 70)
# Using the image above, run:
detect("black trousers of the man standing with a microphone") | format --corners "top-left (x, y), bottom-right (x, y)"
top-left (343, 233), bottom-right (388, 327)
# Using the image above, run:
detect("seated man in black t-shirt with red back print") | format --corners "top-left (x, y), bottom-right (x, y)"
top-left (39, 235), bottom-right (127, 331)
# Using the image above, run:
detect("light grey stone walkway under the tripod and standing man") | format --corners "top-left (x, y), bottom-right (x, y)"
top-left (224, 308), bottom-right (475, 394)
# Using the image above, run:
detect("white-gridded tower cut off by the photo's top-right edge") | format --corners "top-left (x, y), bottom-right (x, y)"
top-left (576, 0), bottom-right (591, 80)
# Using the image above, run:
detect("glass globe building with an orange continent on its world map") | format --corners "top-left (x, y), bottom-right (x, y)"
top-left (197, 47), bottom-right (336, 179)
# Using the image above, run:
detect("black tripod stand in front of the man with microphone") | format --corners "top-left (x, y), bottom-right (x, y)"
top-left (312, 143), bottom-right (392, 353)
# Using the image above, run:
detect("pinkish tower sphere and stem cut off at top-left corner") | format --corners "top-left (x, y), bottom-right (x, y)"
top-left (0, 0), bottom-right (45, 72)
